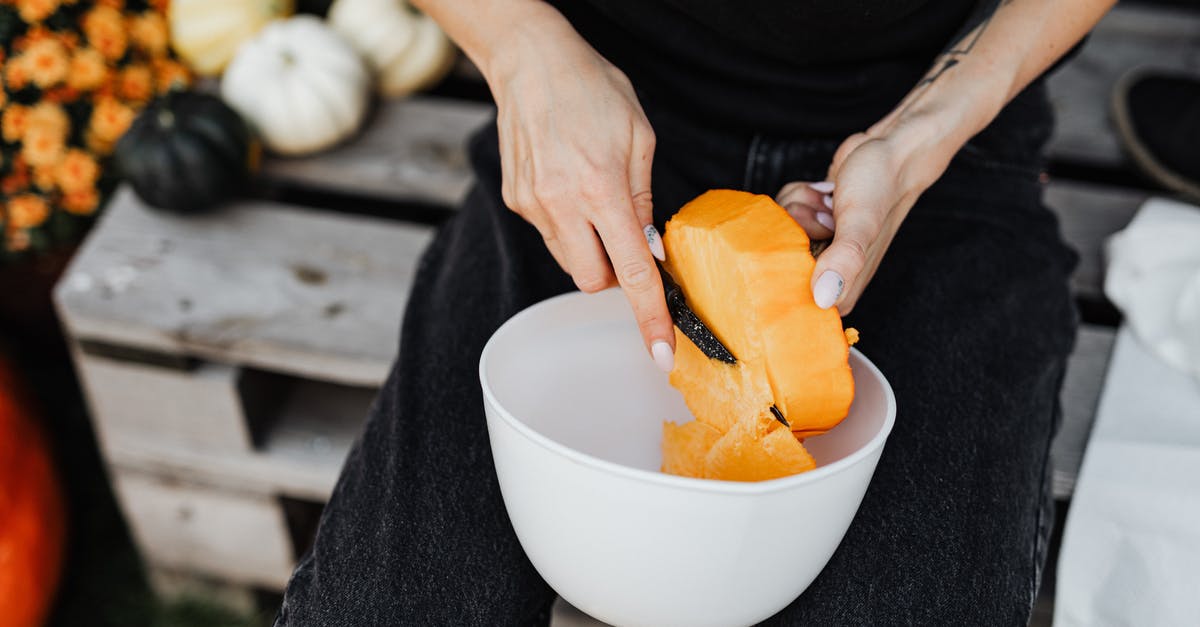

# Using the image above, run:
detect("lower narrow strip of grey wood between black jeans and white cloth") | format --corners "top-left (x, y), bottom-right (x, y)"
top-left (1050, 324), bottom-right (1116, 500)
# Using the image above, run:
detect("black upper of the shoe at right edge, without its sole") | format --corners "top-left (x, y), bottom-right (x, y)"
top-left (1124, 74), bottom-right (1200, 180)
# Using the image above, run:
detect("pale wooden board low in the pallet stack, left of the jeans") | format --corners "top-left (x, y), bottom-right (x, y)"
top-left (112, 472), bottom-right (295, 589)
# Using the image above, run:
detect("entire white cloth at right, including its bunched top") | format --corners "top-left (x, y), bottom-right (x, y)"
top-left (1054, 199), bottom-right (1200, 627)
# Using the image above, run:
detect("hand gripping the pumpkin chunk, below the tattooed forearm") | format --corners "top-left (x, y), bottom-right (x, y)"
top-left (776, 120), bottom-right (949, 316)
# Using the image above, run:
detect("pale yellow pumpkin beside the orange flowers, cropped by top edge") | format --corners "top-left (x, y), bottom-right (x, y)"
top-left (167, 0), bottom-right (293, 76)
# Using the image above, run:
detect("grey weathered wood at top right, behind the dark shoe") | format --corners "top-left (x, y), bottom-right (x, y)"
top-left (1049, 4), bottom-right (1200, 167)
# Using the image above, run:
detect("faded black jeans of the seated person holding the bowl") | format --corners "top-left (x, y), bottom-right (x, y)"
top-left (276, 84), bottom-right (1076, 627)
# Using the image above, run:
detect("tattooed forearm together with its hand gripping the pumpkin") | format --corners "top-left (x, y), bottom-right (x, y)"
top-left (779, 0), bottom-right (1114, 315)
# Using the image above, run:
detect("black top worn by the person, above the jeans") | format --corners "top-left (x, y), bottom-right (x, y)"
top-left (553, 0), bottom-right (996, 137)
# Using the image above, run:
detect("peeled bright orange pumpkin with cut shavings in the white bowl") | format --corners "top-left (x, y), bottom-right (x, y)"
top-left (662, 190), bottom-right (857, 480)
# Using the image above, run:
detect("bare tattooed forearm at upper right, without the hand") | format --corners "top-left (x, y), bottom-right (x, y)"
top-left (868, 0), bottom-right (1115, 183)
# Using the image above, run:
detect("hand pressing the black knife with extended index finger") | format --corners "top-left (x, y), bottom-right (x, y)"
top-left (448, 2), bottom-right (674, 370)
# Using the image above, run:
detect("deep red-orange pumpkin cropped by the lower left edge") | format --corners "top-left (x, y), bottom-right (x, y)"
top-left (0, 350), bottom-right (65, 627)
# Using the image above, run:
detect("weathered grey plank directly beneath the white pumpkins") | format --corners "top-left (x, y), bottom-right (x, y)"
top-left (263, 96), bottom-right (493, 208)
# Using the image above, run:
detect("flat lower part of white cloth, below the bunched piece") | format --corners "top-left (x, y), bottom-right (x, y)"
top-left (1054, 328), bottom-right (1200, 627)
